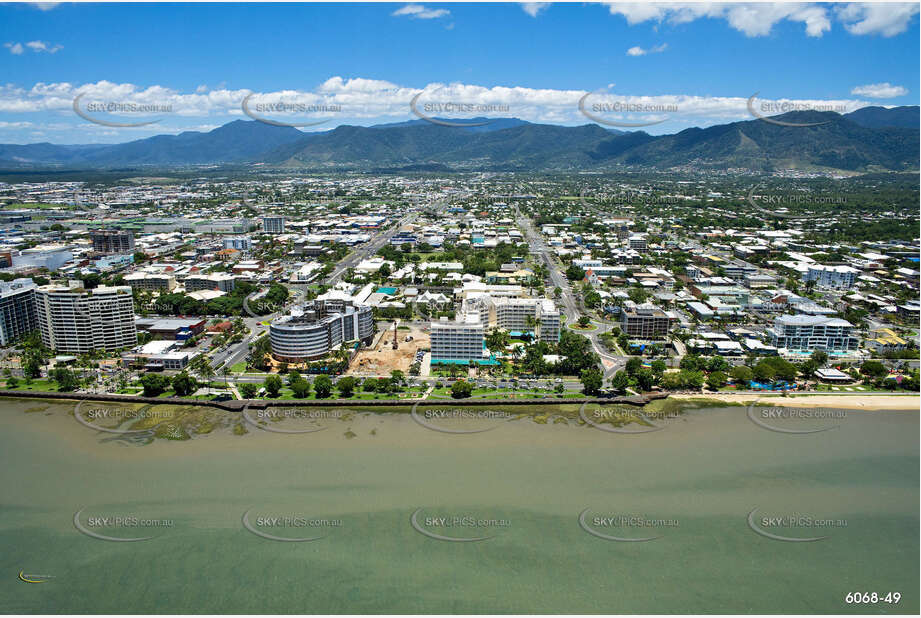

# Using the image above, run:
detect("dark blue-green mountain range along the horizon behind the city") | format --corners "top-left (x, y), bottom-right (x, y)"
top-left (0, 106), bottom-right (919, 171)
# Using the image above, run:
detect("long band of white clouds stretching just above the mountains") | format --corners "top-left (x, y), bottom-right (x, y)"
top-left (0, 76), bottom-right (892, 143)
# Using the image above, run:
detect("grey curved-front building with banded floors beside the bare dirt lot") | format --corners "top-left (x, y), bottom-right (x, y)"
top-left (269, 300), bottom-right (374, 363)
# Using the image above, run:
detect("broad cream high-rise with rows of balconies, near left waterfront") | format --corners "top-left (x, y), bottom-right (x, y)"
top-left (35, 282), bottom-right (137, 354)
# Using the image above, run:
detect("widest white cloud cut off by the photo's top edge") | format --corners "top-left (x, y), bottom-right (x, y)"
top-left (604, 2), bottom-right (831, 37)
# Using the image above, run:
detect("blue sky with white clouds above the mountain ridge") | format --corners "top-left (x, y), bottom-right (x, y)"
top-left (0, 2), bottom-right (919, 143)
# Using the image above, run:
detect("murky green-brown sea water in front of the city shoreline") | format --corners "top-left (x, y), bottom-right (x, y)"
top-left (0, 400), bottom-right (919, 613)
